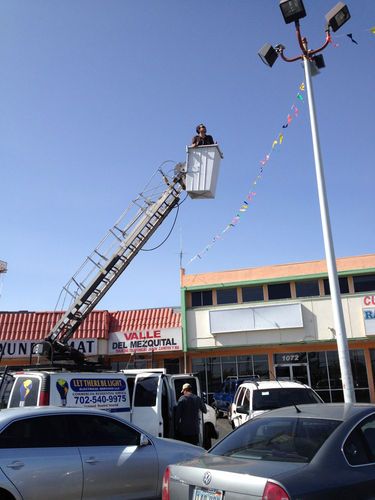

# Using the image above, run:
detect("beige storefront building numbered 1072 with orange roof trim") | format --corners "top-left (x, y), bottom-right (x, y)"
top-left (181, 254), bottom-right (375, 402)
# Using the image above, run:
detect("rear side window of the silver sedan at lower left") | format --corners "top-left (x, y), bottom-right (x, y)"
top-left (0, 415), bottom-right (71, 448)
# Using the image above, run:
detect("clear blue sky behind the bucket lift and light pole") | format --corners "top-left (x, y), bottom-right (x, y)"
top-left (0, 0), bottom-right (375, 311)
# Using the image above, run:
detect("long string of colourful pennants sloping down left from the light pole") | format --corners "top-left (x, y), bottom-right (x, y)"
top-left (186, 82), bottom-right (305, 266)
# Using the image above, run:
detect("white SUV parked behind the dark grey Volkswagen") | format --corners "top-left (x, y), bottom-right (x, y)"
top-left (229, 380), bottom-right (323, 429)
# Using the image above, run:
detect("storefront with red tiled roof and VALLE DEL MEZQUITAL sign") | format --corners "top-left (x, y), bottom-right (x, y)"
top-left (0, 308), bottom-right (183, 373)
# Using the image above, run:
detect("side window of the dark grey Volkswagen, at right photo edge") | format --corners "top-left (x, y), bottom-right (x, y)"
top-left (343, 415), bottom-right (375, 465)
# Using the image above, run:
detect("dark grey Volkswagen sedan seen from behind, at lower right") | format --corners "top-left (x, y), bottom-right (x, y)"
top-left (163, 403), bottom-right (375, 500)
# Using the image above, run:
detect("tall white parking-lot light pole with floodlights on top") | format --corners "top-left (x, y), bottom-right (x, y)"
top-left (259, 0), bottom-right (355, 403)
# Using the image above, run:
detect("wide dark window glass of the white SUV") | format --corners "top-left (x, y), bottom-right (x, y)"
top-left (253, 387), bottom-right (321, 411)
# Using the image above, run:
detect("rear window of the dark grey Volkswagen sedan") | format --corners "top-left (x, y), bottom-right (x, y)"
top-left (209, 417), bottom-right (341, 463)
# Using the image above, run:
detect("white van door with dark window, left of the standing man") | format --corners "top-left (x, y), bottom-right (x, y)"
top-left (131, 373), bottom-right (163, 437)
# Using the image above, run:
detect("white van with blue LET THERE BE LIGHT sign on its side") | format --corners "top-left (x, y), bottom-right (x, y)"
top-left (1, 369), bottom-right (218, 449)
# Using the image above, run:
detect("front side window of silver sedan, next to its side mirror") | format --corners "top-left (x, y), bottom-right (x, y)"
top-left (68, 414), bottom-right (140, 446)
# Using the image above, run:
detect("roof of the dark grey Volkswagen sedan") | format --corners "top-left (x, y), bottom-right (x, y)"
top-left (256, 403), bottom-right (375, 421)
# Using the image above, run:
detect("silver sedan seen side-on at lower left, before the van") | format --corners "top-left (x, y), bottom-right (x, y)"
top-left (0, 406), bottom-right (204, 500)
